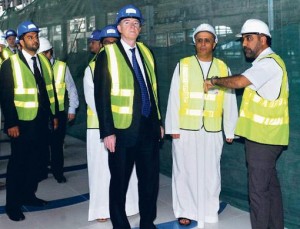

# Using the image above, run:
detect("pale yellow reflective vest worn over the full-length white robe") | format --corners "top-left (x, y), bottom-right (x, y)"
top-left (179, 56), bottom-right (228, 132)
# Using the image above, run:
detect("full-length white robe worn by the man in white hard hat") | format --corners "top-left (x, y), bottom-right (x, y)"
top-left (165, 61), bottom-right (238, 228)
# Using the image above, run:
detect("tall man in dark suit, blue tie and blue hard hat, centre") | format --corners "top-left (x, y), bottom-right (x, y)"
top-left (94, 5), bottom-right (163, 229)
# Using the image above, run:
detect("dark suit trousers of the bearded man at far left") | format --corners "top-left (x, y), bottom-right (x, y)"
top-left (6, 122), bottom-right (48, 210)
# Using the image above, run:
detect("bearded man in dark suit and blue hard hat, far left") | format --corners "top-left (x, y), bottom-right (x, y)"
top-left (0, 21), bottom-right (57, 221)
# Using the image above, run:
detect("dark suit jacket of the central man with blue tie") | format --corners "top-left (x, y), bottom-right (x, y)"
top-left (94, 41), bottom-right (161, 146)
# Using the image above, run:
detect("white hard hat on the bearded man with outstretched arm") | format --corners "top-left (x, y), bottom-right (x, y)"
top-left (236, 19), bottom-right (271, 37)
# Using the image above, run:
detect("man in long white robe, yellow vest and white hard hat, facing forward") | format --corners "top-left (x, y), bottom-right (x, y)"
top-left (166, 24), bottom-right (238, 228)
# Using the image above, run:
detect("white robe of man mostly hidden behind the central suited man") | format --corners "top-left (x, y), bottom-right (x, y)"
top-left (83, 67), bottom-right (139, 221)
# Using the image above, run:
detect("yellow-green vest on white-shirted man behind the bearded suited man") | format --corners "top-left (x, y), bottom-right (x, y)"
top-left (53, 60), bottom-right (67, 111)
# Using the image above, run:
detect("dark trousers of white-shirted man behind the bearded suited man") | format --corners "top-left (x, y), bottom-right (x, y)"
top-left (50, 111), bottom-right (67, 178)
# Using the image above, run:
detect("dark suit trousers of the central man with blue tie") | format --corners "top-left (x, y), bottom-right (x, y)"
top-left (109, 119), bottom-right (159, 229)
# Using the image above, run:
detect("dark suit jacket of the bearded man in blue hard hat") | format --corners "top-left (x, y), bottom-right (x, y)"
top-left (0, 52), bottom-right (53, 138)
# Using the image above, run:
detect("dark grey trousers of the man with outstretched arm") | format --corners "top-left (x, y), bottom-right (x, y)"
top-left (245, 140), bottom-right (284, 229)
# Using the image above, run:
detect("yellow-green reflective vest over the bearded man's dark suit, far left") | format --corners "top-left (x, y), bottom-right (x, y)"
top-left (10, 55), bottom-right (55, 121)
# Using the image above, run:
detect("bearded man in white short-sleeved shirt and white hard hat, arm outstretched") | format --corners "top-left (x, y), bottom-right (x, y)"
top-left (204, 19), bottom-right (289, 229)
